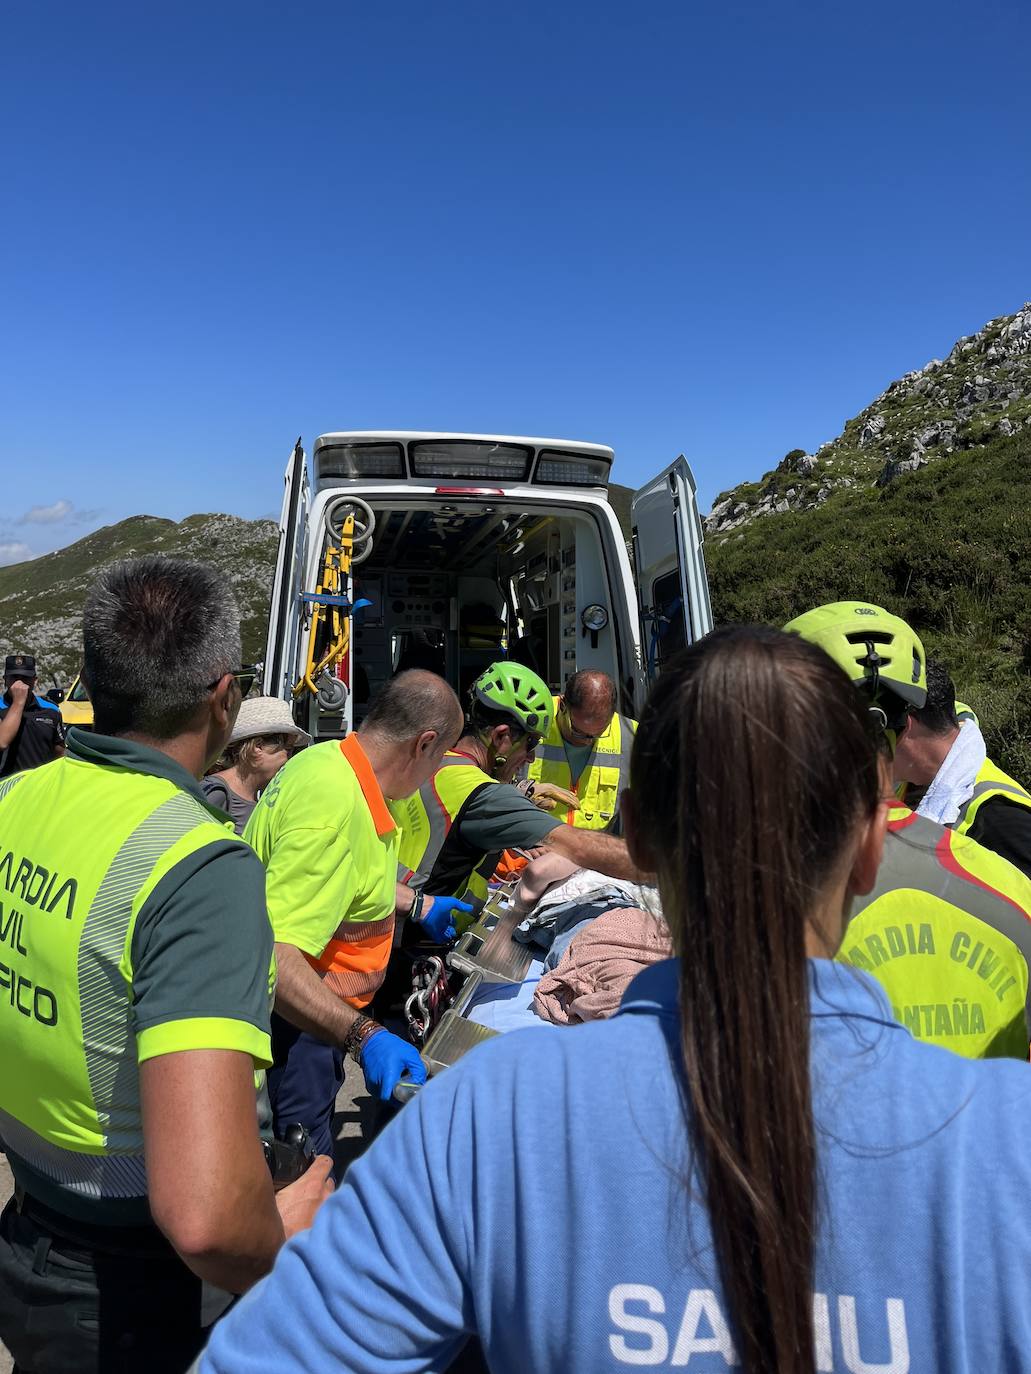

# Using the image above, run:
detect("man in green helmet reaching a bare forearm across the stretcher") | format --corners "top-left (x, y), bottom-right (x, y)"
top-left (392, 662), bottom-right (641, 910)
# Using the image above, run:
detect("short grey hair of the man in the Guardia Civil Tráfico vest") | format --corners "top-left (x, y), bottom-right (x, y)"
top-left (82, 556), bottom-right (241, 739)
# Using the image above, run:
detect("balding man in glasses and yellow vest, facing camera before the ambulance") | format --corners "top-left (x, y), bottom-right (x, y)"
top-left (528, 669), bottom-right (638, 831)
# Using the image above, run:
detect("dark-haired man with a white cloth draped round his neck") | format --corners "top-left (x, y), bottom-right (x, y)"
top-left (894, 658), bottom-right (1031, 878)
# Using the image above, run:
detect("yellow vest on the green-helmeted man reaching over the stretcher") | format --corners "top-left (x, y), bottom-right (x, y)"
top-left (388, 750), bottom-right (500, 910)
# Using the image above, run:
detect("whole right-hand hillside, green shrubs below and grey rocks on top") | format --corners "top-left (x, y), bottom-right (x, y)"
top-left (705, 308), bottom-right (1031, 782)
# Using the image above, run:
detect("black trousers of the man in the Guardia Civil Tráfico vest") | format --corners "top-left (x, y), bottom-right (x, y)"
top-left (0, 1198), bottom-right (209, 1374)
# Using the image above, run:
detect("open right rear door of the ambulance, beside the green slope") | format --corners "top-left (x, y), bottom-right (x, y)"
top-left (630, 453), bottom-right (712, 682)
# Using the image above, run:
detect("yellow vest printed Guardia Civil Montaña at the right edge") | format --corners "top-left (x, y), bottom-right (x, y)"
top-left (837, 804), bottom-right (1031, 1059)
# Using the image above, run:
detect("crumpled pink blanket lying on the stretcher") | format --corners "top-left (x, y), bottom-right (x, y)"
top-left (533, 907), bottom-right (674, 1026)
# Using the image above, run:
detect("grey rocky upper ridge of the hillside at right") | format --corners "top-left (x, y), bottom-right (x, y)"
top-left (704, 302), bottom-right (1031, 536)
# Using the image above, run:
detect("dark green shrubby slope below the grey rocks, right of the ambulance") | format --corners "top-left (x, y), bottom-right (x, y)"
top-left (705, 433), bottom-right (1031, 783)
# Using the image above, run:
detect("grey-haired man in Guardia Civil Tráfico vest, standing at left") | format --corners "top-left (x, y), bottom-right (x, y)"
top-left (0, 558), bottom-right (330, 1374)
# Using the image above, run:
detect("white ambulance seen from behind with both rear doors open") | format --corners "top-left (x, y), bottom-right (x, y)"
top-left (264, 431), bottom-right (712, 739)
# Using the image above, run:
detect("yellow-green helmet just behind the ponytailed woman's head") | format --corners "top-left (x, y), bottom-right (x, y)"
top-left (784, 602), bottom-right (927, 709)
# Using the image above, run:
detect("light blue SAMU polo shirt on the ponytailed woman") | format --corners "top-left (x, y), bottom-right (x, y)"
top-left (199, 960), bottom-right (1031, 1374)
